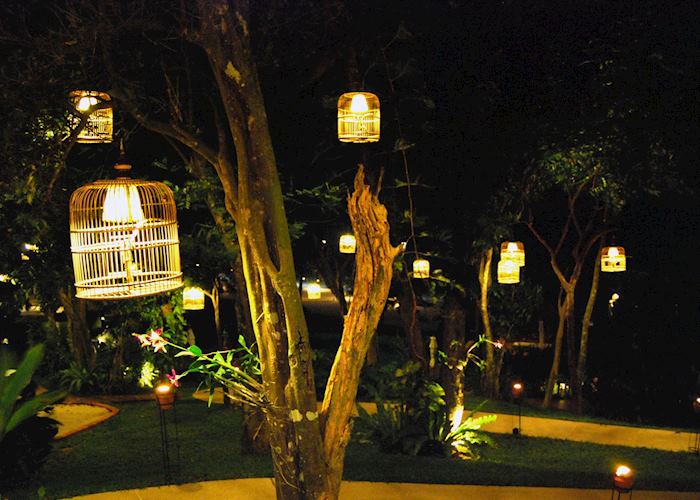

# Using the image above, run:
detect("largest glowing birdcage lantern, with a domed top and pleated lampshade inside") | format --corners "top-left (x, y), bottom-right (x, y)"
top-left (70, 165), bottom-right (182, 300)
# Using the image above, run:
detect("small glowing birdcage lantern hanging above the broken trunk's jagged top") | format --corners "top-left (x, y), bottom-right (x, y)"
top-left (338, 92), bottom-right (380, 142)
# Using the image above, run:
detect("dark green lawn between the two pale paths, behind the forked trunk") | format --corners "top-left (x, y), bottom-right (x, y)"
top-left (8, 399), bottom-right (700, 500)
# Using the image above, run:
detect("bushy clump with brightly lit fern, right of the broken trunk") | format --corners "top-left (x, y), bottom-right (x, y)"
top-left (357, 361), bottom-right (496, 458)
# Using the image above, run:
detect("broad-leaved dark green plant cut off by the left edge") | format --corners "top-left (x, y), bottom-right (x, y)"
top-left (0, 344), bottom-right (65, 487)
